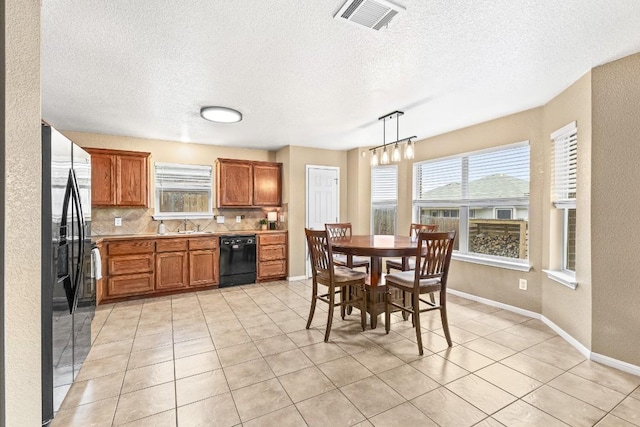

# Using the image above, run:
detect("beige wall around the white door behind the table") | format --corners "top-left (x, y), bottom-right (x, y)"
top-left (276, 146), bottom-right (348, 277)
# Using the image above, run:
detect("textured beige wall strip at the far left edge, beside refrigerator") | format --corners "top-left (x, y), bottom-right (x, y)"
top-left (0, 0), bottom-right (42, 426)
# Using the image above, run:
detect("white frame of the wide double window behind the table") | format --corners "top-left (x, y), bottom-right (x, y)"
top-left (412, 140), bottom-right (532, 272)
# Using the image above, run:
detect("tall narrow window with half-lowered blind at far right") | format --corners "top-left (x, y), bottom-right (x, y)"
top-left (551, 122), bottom-right (578, 275)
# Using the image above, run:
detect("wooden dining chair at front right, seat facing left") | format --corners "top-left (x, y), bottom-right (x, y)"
top-left (385, 231), bottom-right (456, 356)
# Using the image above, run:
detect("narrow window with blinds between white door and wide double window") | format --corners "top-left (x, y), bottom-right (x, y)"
top-left (371, 165), bottom-right (398, 234)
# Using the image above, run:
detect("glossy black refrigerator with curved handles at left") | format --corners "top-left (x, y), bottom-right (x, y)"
top-left (42, 124), bottom-right (96, 426)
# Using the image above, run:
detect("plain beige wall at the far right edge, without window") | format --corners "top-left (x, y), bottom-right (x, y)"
top-left (591, 54), bottom-right (640, 366)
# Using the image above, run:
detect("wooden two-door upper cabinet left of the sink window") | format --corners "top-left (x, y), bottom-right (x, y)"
top-left (85, 148), bottom-right (150, 207)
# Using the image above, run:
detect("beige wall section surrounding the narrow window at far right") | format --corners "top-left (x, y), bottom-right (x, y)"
top-left (541, 72), bottom-right (592, 348)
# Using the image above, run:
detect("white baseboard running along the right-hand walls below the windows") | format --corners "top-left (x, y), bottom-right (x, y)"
top-left (447, 288), bottom-right (640, 376)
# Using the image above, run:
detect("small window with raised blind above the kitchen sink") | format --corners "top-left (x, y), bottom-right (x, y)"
top-left (154, 162), bottom-right (213, 219)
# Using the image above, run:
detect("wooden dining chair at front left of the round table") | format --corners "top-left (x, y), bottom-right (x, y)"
top-left (304, 228), bottom-right (367, 342)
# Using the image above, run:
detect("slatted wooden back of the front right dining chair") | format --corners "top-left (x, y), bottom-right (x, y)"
top-left (414, 231), bottom-right (456, 290)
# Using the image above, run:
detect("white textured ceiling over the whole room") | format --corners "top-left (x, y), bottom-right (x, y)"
top-left (42, 0), bottom-right (640, 149)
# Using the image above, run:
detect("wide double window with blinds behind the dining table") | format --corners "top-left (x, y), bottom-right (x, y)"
top-left (413, 142), bottom-right (529, 265)
